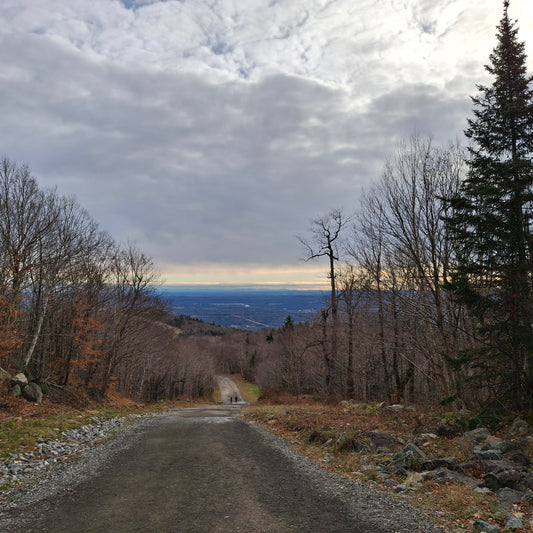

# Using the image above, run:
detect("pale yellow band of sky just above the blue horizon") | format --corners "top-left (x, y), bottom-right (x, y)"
top-left (158, 263), bottom-right (328, 290)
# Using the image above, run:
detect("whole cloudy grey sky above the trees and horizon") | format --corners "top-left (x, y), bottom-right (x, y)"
top-left (0, 0), bottom-right (533, 287)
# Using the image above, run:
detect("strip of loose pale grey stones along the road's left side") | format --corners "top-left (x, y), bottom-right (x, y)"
top-left (0, 415), bottom-right (138, 487)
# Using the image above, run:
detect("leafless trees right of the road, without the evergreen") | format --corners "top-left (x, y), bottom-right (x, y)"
top-left (241, 137), bottom-right (470, 403)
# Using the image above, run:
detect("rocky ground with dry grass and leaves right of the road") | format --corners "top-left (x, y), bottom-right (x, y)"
top-left (245, 402), bottom-right (533, 533)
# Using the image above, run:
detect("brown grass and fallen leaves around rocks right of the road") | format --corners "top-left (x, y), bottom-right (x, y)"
top-left (243, 398), bottom-right (533, 533)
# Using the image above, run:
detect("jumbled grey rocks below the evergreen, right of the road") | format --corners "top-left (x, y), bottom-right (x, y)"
top-left (336, 406), bottom-right (533, 531)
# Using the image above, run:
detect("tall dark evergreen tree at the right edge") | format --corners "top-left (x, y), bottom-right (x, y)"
top-left (446, 1), bottom-right (533, 406)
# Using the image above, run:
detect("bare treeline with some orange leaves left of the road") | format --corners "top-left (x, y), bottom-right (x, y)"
top-left (0, 158), bottom-right (214, 400)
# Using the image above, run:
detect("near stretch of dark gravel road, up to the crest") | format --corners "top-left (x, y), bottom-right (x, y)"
top-left (0, 406), bottom-right (441, 533)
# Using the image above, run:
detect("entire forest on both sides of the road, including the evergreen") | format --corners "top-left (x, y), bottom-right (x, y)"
top-left (0, 3), bottom-right (533, 411)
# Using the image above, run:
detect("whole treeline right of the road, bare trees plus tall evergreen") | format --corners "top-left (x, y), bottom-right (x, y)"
top-left (242, 2), bottom-right (533, 410)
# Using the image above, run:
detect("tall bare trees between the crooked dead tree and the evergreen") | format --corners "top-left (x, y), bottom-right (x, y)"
top-left (351, 136), bottom-right (463, 399)
